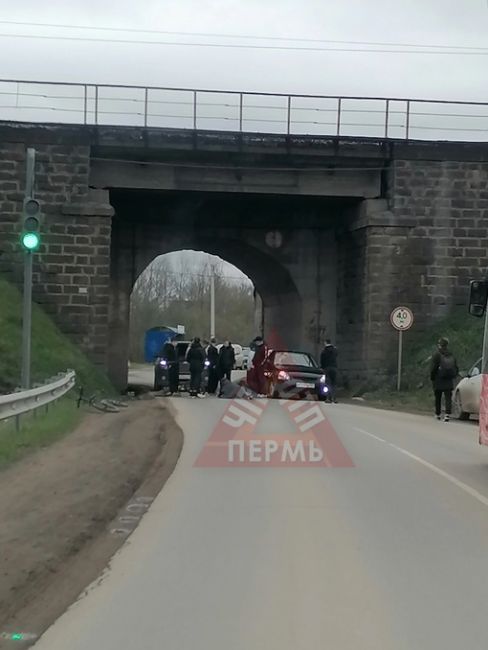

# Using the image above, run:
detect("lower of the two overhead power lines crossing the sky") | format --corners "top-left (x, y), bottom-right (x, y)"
top-left (0, 33), bottom-right (488, 56)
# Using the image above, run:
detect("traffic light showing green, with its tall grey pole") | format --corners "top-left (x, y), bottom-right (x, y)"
top-left (21, 148), bottom-right (41, 388)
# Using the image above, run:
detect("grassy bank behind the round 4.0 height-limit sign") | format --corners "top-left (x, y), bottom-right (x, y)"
top-left (355, 309), bottom-right (484, 413)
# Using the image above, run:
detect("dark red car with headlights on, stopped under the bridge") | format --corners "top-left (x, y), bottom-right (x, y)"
top-left (258, 350), bottom-right (329, 401)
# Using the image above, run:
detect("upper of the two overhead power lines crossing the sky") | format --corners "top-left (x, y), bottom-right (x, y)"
top-left (0, 20), bottom-right (488, 52)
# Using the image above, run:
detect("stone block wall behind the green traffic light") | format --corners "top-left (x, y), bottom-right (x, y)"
top-left (0, 143), bottom-right (111, 365)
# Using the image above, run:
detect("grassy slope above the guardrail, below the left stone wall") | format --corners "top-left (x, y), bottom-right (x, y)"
top-left (0, 277), bottom-right (114, 394)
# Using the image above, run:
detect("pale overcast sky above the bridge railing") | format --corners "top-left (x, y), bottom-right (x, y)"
top-left (0, 0), bottom-right (488, 100)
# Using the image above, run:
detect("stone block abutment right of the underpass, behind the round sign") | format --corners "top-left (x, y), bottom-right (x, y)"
top-left (346, 160), bottom-right (488, 378)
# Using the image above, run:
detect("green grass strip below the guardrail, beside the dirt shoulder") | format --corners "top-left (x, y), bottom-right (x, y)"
top-left (0, 396), bottom-right (83, 468)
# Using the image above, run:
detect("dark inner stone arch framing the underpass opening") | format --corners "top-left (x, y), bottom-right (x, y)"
top-left (108, 224), bottom-right (302, 387)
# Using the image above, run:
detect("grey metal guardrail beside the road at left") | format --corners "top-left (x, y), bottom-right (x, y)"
top-left (0, 370), bottom-right (76, 429)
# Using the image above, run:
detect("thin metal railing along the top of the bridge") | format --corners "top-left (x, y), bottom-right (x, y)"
top-left (0, 80), bottom-right (488, 141)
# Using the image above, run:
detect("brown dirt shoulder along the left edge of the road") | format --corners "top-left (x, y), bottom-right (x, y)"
top-left (0, 399), bottom-right (183, 648)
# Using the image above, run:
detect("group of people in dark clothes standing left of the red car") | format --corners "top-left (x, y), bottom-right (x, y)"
top-left (161, 336), bottom-right (235, 397)
